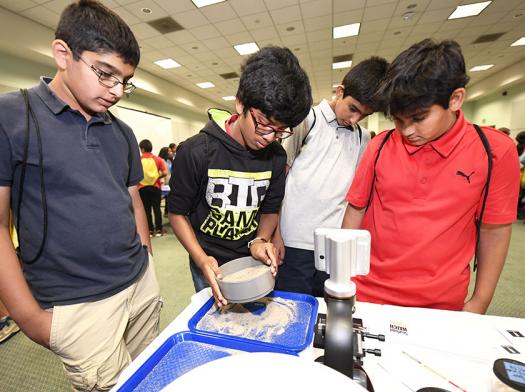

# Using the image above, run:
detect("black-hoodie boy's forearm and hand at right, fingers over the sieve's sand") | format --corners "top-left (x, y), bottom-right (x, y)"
top-left (250, 213), bottom-right (279, 276)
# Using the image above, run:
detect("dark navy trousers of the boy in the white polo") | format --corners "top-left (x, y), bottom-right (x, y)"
top-left (275, 246), bottom-right (329, 297)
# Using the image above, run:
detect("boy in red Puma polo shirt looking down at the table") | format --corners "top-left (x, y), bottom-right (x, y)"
top-left (342, 39), bottom-right (519, 313)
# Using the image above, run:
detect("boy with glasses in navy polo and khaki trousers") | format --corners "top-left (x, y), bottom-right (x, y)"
top-left (0, 1), bottom-right (162, 391)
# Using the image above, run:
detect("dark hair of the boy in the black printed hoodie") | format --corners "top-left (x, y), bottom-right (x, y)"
top-left (237, 46), bottom-right (312, 127)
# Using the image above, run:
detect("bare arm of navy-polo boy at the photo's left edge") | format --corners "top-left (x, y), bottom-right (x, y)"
top-left (0, 187), bottom-right (52, 347)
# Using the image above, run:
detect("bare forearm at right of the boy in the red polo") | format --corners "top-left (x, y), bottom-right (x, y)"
top-left (463, 224), bottom-right (512, 314)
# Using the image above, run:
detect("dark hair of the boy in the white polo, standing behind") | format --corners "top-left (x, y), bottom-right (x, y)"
top-left (341, 56), bottom-right (388, 112)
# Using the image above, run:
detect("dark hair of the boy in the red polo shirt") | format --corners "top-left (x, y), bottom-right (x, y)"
top-left (378, 38), bottom-right (469, 114)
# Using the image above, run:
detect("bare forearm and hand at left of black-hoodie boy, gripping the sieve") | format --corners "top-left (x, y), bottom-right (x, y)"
top-left (168, 212), bottom-right (228, 307)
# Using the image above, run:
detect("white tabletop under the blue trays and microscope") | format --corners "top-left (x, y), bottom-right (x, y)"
top-left (113, 289), bottom-right (525, 392)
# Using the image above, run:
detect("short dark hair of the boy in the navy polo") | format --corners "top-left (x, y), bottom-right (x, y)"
top-left (55, 0), bottom-right (140, 67)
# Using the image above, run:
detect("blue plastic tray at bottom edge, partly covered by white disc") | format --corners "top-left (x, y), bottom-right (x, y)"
top-left (118, 331), bottom-right (297, 392)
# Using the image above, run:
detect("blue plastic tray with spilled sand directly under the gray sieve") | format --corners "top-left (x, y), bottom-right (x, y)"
top-left (188, 291), bottom-right (318, 352)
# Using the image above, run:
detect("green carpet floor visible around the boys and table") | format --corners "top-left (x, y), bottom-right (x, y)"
top-left (0, 222), bottom-right (525, 392)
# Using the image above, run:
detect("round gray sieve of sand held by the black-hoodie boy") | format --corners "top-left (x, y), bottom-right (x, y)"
top-left (217, 256), bottom-right (275, 304)
